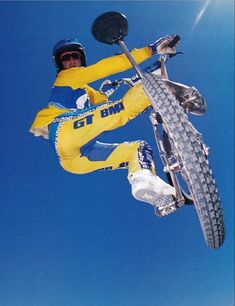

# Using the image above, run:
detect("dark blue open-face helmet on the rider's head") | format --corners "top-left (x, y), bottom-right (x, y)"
top-left (52, 38), bottom-right (86, 71)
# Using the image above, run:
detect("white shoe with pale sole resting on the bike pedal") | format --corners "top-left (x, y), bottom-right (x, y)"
top-left (129, 169), bottom-right (176, 215)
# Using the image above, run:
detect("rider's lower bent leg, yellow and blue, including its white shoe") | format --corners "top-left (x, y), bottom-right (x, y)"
top-left (55, 137), bottom-right (175, 208)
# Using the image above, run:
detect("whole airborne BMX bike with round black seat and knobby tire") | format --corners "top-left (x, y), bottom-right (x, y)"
top-left (92, 12), bottom-right (225, 249)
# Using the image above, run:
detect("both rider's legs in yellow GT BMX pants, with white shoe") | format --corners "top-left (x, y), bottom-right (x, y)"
top-left (50, 84), bottom-right (174, 208)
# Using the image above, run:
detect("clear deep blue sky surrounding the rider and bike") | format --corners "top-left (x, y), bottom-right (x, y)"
top-left (0, 0), bottom-right (234, 306)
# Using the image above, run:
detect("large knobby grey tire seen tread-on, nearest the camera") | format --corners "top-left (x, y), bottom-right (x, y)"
top-left (142, 73), bottom-right (225, 249)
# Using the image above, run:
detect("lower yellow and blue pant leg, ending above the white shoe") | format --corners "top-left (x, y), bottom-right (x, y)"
top-left (57, 141), bottom-right (155, 177)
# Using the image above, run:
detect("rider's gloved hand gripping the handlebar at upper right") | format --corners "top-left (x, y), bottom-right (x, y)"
top-left (148, 35), bottom-right (177, 54)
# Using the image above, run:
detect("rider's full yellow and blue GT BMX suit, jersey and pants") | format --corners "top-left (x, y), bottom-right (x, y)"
top-left (30, 47), bottom-right (154, 175)
